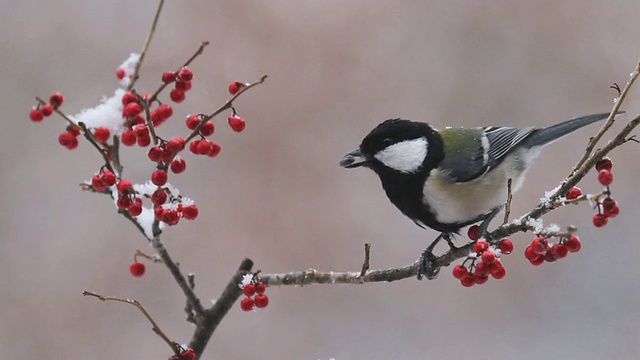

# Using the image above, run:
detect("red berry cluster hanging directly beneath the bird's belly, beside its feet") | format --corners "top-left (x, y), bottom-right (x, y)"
top-left (453, 225), bottom-right (513, 287)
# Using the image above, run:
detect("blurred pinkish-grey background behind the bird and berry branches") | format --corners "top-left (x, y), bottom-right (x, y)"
top-left (0, 0), bottom-right (640, 360)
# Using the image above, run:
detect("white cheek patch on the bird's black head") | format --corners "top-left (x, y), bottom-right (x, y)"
top-left (374, 137), bottom-right (428, 173)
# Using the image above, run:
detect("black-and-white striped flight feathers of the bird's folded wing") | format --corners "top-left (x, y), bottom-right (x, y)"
top-left (483, 126), bottom-right (536, 169)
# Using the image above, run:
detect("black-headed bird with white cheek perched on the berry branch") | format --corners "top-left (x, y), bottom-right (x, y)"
top-left (339, 112), bottom-right (623, 280)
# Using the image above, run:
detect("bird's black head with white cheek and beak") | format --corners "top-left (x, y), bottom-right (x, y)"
top-left (340, 119), bottom-right (442, 174)
